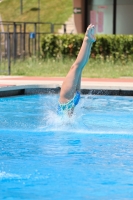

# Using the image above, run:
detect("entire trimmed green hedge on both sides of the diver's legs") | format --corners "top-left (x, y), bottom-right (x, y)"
top-left (42, 34), bottom-right (133, 63)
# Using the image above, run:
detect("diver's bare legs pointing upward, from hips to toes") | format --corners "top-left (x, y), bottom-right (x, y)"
top-left (59, 25), bottom-right (95, 103)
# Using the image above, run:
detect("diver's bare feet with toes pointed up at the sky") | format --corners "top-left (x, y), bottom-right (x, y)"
top-left (85, 24), bottom-right (96, 42)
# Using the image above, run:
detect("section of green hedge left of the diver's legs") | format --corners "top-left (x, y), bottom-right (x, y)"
top-left (42, 34), bottom-right (83, 58)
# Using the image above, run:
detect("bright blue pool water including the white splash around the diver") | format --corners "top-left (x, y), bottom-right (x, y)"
top-left (0, 94), bottom-right (133, 200)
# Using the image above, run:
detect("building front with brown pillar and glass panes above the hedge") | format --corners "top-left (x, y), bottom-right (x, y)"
top-left (73, 0), bottom-right (133, 34)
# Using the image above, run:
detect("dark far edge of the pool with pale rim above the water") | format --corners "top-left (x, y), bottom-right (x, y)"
top-left (0, 84), bottom-right (133, 97)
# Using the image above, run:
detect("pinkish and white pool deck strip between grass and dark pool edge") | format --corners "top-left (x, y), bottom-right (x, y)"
top-left (0, 76), bottom-right (133, 96)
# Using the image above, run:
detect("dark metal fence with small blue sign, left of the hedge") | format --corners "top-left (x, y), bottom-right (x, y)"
top-left (0, 22), bottom-right (67, 75)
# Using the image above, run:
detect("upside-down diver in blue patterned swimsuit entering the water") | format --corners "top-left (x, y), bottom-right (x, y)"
top-left (58, 24), bottom-right (96, 117)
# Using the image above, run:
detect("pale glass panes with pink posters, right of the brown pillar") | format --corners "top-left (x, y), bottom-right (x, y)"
top-left (86, 0), bottom-right (133, 34)
